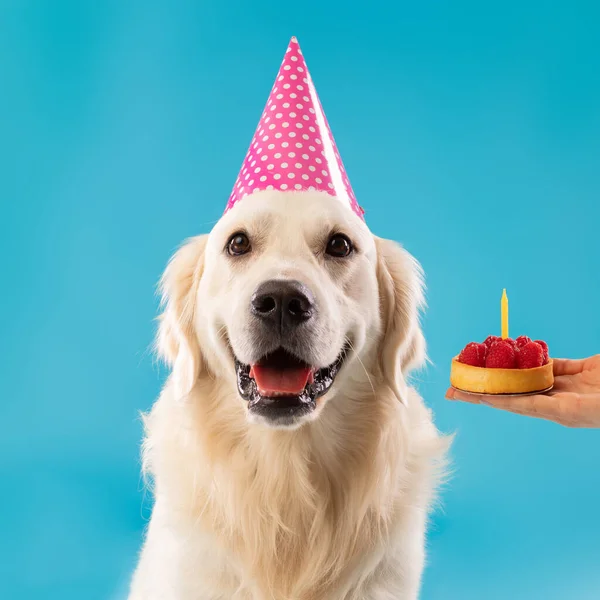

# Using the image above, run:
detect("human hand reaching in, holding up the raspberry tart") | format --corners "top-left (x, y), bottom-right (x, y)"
top-left (446, 354), bottom-right (600, 427)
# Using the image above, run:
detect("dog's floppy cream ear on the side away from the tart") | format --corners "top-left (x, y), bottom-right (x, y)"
top-left (156, 235), bottom-right (208, 396)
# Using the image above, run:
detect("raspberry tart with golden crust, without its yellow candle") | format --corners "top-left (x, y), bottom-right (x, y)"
top-left (450, 335), bottom-right (554, 394)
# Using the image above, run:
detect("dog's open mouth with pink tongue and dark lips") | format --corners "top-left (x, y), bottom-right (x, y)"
top-left (235, 346), bottom-right (349, 424)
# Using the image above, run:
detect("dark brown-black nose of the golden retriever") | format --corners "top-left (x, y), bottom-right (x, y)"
top-left (251, 279), bottom-right (315, 328)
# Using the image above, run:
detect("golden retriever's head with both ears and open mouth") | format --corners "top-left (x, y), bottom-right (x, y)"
top-left (158, 192), bottom-right (424, 428)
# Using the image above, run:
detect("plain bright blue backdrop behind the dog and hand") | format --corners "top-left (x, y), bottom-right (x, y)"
top-left (0, 0), bottom-right (600, 600)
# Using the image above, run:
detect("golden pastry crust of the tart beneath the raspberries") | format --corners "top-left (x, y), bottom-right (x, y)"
top-left (450, 356), bottom-right (554, 394)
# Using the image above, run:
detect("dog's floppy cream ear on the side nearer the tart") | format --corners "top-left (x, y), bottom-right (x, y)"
top-left (375, 237), bottom-right (426, 404)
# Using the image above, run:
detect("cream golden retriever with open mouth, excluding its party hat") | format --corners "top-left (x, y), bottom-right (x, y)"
top-left (129, 191), bottom-right (449, 600)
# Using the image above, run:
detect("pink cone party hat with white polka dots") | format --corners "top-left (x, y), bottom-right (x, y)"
top-left (225, 37), bottom-right (364, 219)
